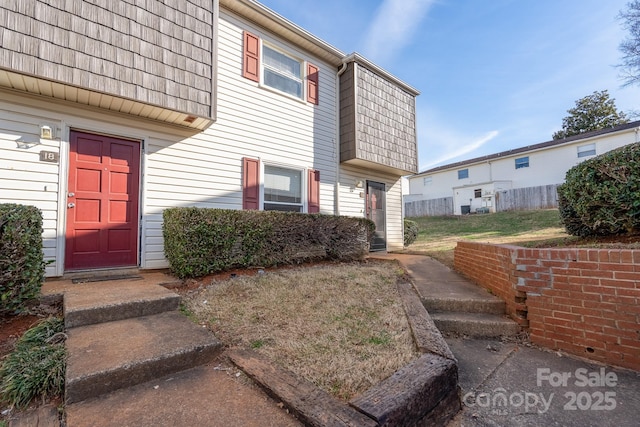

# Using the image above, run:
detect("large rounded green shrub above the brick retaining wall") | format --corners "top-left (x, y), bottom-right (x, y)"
top-left (558, 143), bottom-right (640, 237)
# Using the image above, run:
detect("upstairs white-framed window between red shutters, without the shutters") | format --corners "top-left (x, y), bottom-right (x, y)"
top-left (262, 43), bottom-right (304, 99)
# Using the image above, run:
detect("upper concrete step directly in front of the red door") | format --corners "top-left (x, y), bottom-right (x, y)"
top-left (64, 280), bottom-right (180, 329)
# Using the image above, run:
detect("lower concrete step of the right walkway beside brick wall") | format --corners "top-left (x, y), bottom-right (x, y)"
top-left (429, 311), bottom-right (520, 337)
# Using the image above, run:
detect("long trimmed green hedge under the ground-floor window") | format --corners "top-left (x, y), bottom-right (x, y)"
top-left (163, 207), bottom-right (375, 278)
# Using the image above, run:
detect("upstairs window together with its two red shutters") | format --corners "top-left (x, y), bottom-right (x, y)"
top-left (242, 31), bottom-right (319, 105)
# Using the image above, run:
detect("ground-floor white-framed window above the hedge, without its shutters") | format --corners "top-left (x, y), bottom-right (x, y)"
top-left (262, 164), bottom-right (304, 212)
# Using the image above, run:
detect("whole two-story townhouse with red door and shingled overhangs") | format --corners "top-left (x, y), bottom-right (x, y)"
top-left (0, 0), bottom-right (418, 276)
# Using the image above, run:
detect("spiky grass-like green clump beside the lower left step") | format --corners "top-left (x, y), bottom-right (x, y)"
top-left (0, 317), bottom-right (66, 408)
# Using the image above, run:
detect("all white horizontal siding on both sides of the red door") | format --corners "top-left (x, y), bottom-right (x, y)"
top-left (0, 11), bottom-right (340, 276)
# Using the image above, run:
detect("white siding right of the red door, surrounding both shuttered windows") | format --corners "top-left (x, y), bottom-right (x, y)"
top-left (143, 11), bottom-right (337, 268)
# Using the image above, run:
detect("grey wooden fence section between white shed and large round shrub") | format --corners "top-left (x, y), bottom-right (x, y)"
top-left (495, 184), bottom-right (560, 212)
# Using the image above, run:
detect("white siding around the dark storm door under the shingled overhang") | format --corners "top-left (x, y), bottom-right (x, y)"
top-left (338, 164), bottom-right (404, 251)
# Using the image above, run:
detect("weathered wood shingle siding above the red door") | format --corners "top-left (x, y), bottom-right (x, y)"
top-left (0, 0), bottom-right (215, 117)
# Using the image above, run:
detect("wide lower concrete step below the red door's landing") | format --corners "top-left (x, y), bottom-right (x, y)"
top-left (65, 311), bottom-right (222, 404)
